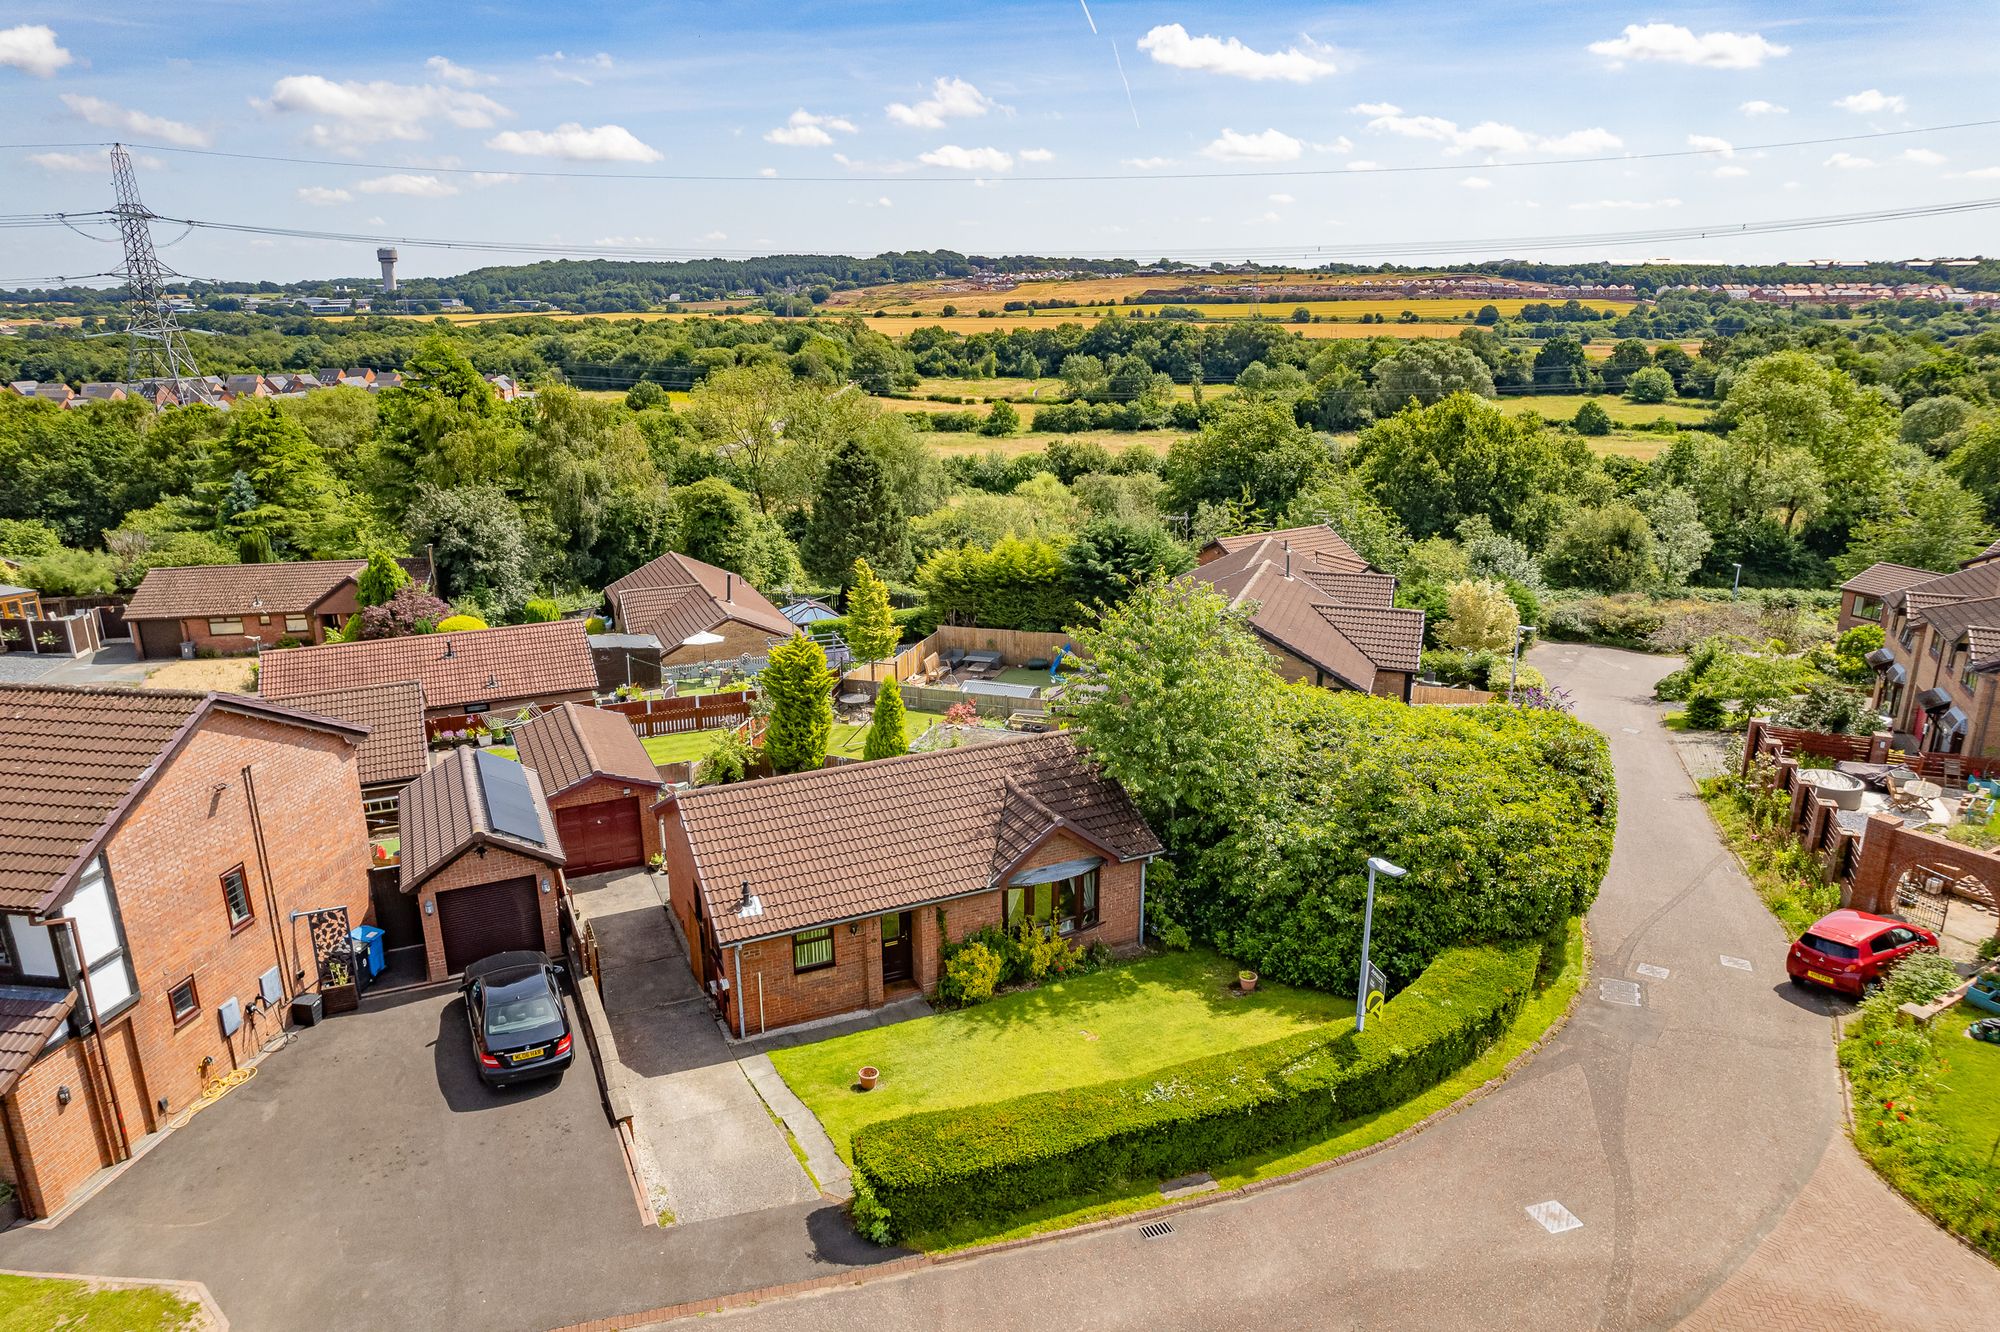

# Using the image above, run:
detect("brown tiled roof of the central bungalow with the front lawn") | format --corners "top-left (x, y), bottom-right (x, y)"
top-left (672, 732), bottom-right (1160, 944)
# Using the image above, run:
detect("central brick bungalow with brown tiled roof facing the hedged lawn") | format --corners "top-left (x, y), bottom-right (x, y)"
top-left (662, 734), bottom-right (1160, 1036)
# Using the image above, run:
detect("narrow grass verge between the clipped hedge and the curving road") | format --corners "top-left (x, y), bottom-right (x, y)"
top-left (884, 920), bottom-right (1590, 1254)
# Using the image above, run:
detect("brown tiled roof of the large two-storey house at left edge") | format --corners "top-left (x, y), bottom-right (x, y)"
top-left (0, 684), bottom-right (366, 912)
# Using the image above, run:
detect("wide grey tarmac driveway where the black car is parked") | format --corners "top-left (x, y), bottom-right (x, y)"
top-left (0, 972), bottom-right (880, 1332)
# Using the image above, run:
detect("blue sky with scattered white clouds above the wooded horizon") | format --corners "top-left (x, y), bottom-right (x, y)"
top-left (0, 0), bottom-right (2000, 284)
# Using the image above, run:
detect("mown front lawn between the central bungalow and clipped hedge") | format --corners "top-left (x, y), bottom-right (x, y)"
top-left (770, 950), bottom-right (1354, 1158)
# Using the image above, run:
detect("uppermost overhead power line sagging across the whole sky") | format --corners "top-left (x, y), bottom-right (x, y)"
top-left (11, 120), bottom-right (2000, 184)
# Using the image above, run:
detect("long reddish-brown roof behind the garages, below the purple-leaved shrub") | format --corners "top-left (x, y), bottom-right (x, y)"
top-left (258, 620), bottom-right (598, 708)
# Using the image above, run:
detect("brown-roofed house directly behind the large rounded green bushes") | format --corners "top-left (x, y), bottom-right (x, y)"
top-left (1186, 524), bottom-right (1424, 702)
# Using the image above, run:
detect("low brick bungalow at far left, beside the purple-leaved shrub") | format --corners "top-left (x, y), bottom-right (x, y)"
top-left (124, 560), bottom-right (428, 660)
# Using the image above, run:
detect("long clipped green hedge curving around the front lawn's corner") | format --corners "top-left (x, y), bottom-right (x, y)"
top-left (854, 942), bottom-right (1542, 1242)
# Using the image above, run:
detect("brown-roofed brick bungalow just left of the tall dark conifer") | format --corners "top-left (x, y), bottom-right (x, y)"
top-left (604, 552), bottom-right (798, 666)
